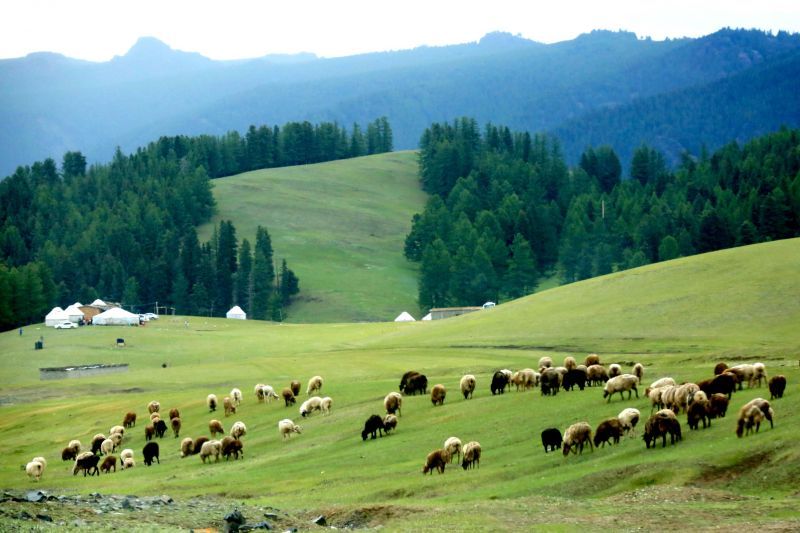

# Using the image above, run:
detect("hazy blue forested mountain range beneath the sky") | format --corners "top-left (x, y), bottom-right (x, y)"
top-left (0, 29), bottom-right (800, 175)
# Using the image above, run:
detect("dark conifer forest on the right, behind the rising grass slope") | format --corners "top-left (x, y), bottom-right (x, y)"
top-left (405, 118), bottom-right (800, 308)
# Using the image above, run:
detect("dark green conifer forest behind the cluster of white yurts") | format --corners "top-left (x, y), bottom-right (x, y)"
top-left (0, 118), bottom-right (392, 329)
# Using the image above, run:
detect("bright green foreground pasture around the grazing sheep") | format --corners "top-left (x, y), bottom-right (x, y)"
top-left (0, 239), bottom-right (800, 530)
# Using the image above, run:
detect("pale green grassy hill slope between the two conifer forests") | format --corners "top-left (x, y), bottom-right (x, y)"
top-left (199, 152), bottom-right (426, 322)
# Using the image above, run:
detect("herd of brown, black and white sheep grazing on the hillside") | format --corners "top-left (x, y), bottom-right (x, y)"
top-left (24, 354), bottom-right (786, 481)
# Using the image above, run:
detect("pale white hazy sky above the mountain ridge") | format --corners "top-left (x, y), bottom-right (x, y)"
top-left (0, 0), bottom-right (800, 61)
